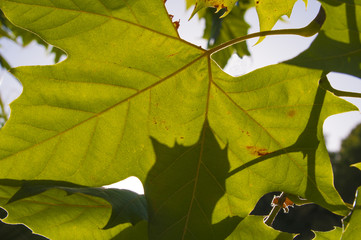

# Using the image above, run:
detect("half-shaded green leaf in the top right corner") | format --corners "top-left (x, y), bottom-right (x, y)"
top-left (288, 0), bottom-right (361, 78)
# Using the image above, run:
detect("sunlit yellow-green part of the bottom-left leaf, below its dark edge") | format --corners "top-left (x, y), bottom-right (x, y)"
top-left (0, 186), bottom-right (132, 240)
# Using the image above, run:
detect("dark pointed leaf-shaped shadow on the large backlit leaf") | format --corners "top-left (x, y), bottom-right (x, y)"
top-left (144, 123), bottom-right (241, 240)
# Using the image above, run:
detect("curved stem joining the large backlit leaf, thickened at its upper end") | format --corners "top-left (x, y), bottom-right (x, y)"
top-left (208, 7), bottom-right (326, 55)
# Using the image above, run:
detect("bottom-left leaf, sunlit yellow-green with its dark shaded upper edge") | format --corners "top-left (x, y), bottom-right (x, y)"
top-left (0, 180), bottom-right (146, 240)
